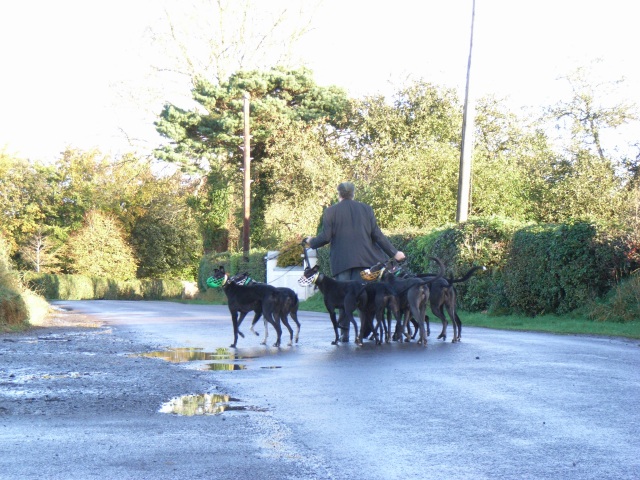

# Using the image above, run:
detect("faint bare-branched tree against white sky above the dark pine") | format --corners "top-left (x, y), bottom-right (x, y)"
top-left (151, 0), bottom-right (315, 84)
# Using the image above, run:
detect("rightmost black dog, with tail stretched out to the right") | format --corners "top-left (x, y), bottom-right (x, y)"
top-left (417, 266), bottom-right (487, 343)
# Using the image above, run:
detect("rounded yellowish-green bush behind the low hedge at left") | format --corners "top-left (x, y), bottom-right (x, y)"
top-left (65, 211), bottom-right (137, 280)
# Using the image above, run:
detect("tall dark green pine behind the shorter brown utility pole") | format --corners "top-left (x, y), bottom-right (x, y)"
top-left (156, 68), bottom-right (349, 248)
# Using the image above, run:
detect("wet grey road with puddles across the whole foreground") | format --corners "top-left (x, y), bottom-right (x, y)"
top-left (0, 301), bottom-right (640, 480)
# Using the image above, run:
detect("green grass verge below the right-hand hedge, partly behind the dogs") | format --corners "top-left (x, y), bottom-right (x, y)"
top-left (300, 293), bottom-right (640, 338)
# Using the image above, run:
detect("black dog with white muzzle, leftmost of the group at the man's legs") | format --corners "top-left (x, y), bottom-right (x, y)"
top-left (298, 265), bottom-right (364, 345)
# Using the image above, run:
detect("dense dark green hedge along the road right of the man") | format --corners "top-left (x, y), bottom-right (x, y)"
top-left (405, 218), bottom-right (640, 315)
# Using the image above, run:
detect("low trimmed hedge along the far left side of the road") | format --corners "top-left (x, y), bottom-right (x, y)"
top-left (24, 272), bottom-right (182, 300)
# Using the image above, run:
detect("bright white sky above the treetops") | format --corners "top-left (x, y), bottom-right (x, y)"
top-left (0, 0), bottom-right (640, 160)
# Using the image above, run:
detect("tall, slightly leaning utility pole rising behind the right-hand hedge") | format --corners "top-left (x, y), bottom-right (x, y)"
top-left (456, 0), bottom-right (476, 222)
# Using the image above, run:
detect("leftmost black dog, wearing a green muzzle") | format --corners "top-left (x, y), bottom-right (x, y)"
top-left (213, 265), bottom-right (282, 348)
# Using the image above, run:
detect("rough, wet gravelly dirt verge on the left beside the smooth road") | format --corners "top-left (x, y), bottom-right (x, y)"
top-left (0, 311), bottom-right (326, 480)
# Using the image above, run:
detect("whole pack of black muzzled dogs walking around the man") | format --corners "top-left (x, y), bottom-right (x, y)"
top-left (207, 245), bottom-right (486, 348)
